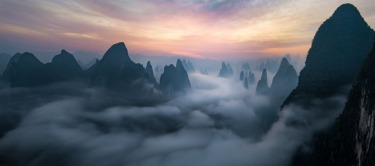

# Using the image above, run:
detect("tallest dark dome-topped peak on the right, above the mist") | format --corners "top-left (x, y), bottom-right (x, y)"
top-left (285, 4), bottom-right (374, 104)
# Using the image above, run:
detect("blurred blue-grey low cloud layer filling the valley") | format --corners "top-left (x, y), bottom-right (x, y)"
top-left (0, 74), bottom-right (345, 166)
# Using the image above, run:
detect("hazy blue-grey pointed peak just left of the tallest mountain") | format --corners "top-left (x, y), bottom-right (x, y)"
top-left (270, 58), bottom-right (298, 96)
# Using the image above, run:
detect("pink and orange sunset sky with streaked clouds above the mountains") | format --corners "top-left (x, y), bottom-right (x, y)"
top-left (0, 0), bottom-right (375, 60)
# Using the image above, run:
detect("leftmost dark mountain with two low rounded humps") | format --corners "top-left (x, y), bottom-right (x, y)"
top-left (3, 50), bottom-right (83, 87)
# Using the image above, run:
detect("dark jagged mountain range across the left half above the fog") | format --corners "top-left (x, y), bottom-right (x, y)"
top-left (2, 42), bottom-right (190, 94)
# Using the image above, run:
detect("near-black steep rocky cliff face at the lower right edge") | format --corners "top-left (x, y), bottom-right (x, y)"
top-left (318, 40), bottom-right (375, 166)
